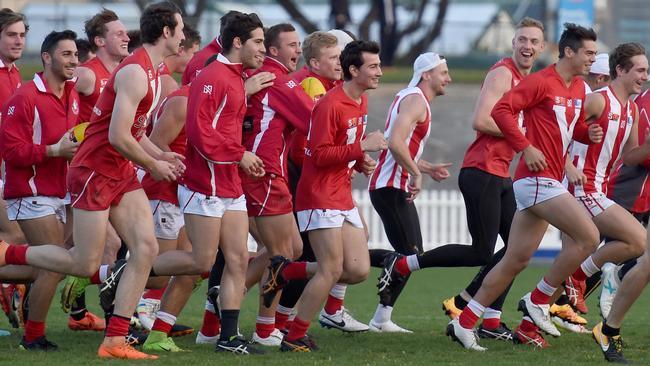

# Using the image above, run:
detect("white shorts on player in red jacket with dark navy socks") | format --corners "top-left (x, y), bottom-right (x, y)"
top-left (178, 184), bottom-right (247, 218)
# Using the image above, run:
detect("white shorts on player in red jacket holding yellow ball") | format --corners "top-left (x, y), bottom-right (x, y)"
top-left (6, 196), bottom-right (70, 223)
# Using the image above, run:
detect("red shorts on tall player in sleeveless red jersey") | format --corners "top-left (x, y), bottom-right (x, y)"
top-left (68, 167), bottom-right (142, 211)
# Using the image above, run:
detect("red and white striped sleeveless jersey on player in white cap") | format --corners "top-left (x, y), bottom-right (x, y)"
top-left (368, 87), bottom-right (431, 192)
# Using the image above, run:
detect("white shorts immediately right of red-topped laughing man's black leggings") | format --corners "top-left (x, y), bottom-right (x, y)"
top-left (512, 177), bottom-right (569, 211)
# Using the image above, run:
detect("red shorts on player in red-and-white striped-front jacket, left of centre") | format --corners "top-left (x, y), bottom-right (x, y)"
top-left (242, 175), bottom-right (293, 217)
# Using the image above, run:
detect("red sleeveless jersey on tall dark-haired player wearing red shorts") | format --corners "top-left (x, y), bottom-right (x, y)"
top-left (71, 47), bottom-right (160, 180)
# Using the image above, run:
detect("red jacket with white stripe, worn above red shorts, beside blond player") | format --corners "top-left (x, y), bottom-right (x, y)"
top-left (243, 57), bottom-right (314, 179)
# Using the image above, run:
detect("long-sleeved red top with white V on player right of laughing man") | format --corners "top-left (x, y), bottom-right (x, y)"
top-left (492, 64), bottom-right (591, 181)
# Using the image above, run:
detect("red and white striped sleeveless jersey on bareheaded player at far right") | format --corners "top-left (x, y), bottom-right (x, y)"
top-left (568, 86), bottom-right (636, 197)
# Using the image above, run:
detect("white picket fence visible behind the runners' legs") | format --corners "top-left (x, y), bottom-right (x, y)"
top-left (352, 190), bottom-right (561, 251)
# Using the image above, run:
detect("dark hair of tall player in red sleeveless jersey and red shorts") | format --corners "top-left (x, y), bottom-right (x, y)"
top-left (140, 2), bottom-right (181, 44)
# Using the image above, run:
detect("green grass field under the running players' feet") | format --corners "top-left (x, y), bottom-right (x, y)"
top-left (0, 266), bottom-right (650, 366)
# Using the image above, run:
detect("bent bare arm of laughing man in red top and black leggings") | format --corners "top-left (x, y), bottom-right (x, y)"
top-left (472, 67), bottom-right (512, 137)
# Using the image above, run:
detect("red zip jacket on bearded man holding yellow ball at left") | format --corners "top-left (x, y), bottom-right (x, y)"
top-left (0, 73), bottom-right (79, 198)
